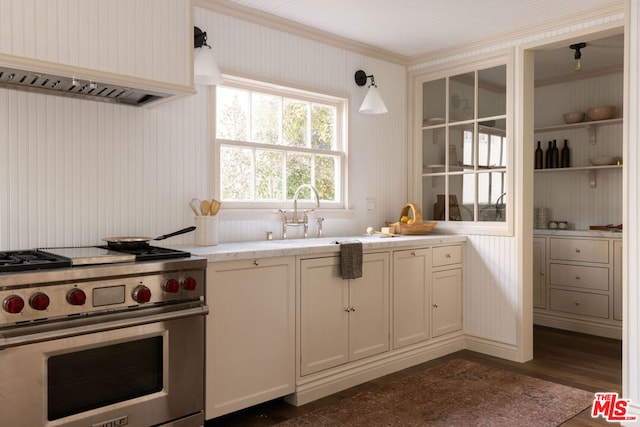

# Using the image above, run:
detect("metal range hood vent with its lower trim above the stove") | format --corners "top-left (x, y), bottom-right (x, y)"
top-left (0, 55), bottom-right (195, 107)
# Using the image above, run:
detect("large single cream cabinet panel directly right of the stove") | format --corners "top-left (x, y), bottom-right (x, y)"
top-left (205, 257), bottom-right (295, 419)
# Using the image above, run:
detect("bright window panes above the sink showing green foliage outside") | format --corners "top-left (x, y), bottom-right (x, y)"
top-left (216, 79), bottom-right (347, 208)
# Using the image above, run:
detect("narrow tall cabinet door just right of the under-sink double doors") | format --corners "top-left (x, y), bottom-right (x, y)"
top-left (393, 248), bottom-right (431, 349)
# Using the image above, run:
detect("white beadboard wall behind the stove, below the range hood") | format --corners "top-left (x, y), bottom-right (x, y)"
top-left (0, 89), bottom-right (209, 250)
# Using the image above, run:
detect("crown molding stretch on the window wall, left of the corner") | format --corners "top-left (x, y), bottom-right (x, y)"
top-left (193, 0), bottom-right (408, 67)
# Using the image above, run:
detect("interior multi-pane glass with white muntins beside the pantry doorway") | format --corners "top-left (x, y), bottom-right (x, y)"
top-left (413, 57), bottom-right (513, 234)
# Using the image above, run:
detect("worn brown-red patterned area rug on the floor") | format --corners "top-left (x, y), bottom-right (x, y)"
top-left (278, 359), bottom-right (594, 427)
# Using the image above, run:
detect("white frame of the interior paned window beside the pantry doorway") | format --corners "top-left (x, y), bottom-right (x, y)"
top-left (408, 49), bottom-right (521, 236)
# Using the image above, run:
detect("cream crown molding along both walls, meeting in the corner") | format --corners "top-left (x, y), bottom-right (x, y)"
top-left (193, 0), bottom-right (625, 67)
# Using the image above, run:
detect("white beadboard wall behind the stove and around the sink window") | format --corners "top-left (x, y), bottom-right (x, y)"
top-left (0, 8), bottom-right (406, 250)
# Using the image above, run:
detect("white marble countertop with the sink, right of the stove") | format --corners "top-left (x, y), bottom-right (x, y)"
top-left (167, 234), bottom-right (467, 262)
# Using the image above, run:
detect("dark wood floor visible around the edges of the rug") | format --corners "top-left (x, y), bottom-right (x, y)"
top-left (206, 326), bottom-right (622, 427)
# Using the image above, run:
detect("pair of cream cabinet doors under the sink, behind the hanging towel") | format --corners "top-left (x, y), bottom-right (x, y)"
top-left (300, 252), bottom-right (390, 376)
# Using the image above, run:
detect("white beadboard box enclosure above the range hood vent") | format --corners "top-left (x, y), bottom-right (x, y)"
top-left (0, 0), bottom-right (194, 91)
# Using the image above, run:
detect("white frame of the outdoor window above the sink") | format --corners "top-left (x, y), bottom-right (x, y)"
top-left (209, 75), bottom-right (349, 214)
